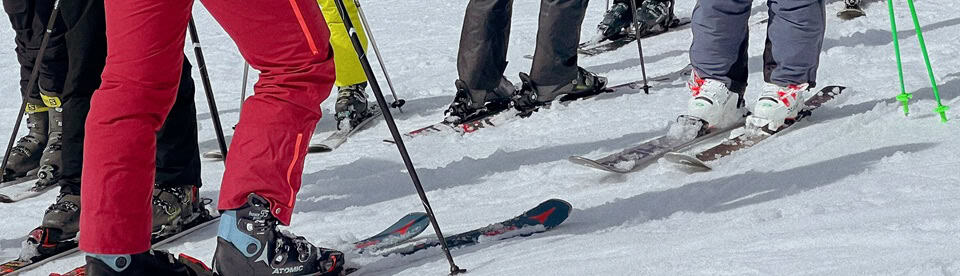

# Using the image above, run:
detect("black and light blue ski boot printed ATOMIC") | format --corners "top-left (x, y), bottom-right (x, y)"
top-left (213, 194), bottom-right (344, 276)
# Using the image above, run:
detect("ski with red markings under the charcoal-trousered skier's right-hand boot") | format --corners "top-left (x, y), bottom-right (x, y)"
top-left (383, 65), bottom-right (692, 143)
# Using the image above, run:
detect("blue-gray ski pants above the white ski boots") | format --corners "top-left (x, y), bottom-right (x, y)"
top-left (690, 0), bottom-right (826, 92)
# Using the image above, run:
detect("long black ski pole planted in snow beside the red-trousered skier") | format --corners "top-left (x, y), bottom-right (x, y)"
top-left (334, 0), bottom-right (467, 275)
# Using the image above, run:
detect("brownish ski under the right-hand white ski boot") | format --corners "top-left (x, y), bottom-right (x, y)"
top-left (664, 85), bottom-right (846, 171)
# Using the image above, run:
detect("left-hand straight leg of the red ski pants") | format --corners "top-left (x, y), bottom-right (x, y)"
top-left (80, 0), bottom-right (193, 254)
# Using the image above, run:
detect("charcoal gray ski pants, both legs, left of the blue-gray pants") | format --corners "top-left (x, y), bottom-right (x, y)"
top-left (457, 0), bottom-right (588, 94)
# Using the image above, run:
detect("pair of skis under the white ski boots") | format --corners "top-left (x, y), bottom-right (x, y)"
top-left (569, 86), bottom-right (845, 173)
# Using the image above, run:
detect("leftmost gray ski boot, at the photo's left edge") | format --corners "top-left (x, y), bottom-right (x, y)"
top-left (3, 104), bottom-right (49, 182)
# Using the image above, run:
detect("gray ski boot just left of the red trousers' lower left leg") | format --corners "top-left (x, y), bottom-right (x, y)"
top-left (20, 193), bottom-right (80, 260)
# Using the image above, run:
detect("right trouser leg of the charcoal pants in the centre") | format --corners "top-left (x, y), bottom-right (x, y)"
top-left (530, 0), bottom-right (588, 86)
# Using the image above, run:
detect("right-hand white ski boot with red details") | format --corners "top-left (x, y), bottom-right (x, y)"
top-left (746, 83), bottom-right (810, 135)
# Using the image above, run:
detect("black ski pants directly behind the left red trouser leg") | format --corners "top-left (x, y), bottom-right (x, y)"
top-left (60, 0), bottom-right (200, 194)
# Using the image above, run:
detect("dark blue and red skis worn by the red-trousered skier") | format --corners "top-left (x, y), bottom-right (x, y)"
top-left (43, 199), bottom-right (573, 276)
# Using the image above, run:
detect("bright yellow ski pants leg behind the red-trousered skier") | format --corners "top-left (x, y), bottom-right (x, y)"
top-left (317, 0), bottom-right (367, 87)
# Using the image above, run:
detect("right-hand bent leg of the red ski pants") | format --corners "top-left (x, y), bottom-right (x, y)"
top-left (203, 0), bottom-right (335, 224)
